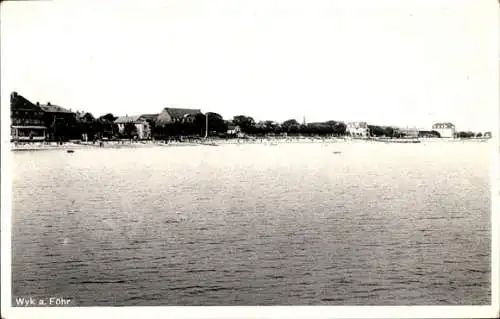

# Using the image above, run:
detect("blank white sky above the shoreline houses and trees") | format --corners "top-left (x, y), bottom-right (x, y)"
top-left (0, 0), bottom-right (499, 131)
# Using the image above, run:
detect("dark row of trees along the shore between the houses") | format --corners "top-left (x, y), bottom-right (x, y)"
top-left (41, 111), bottom-right (491, 141)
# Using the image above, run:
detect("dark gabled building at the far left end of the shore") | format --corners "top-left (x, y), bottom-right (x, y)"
top-left (10, 92), bottom-right (47, 141)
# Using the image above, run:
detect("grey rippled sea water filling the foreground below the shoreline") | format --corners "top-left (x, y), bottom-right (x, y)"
top-left (12, 142), bottom-right (491, 306)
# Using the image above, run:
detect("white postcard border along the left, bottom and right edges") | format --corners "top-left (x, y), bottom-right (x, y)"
top-left (0, 1), bottom-right (500, 319)
